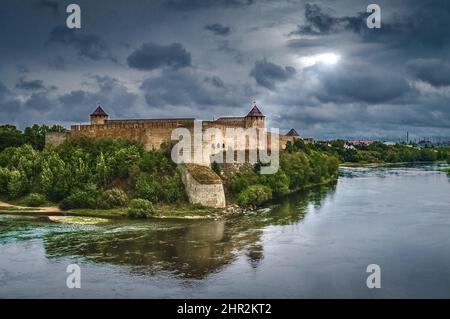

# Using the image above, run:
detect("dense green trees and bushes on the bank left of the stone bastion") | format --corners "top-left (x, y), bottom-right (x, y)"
top-left (0, 138), bottom-right (186, 215)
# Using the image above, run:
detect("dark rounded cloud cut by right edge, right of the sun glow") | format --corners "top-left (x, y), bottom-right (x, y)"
top-left (407, 59), bottom-right (450, 87)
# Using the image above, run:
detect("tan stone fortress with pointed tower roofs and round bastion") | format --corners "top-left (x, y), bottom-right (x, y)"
top-left (46, 103), bottom-right (299, 208)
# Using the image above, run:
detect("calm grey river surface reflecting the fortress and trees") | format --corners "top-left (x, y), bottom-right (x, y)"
top-left (0, 166), bottom-right (450, 298)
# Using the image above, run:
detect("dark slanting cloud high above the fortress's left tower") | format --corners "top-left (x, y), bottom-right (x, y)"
top-left (49, 26), bottom-right (116, 62)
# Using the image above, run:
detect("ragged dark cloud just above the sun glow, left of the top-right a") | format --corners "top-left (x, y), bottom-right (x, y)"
top-left (290, 3), bottom-right (367, 35)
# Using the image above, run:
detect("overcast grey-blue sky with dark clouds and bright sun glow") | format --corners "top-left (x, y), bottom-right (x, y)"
top-left (0, 0), bottom-right (450, 139)
